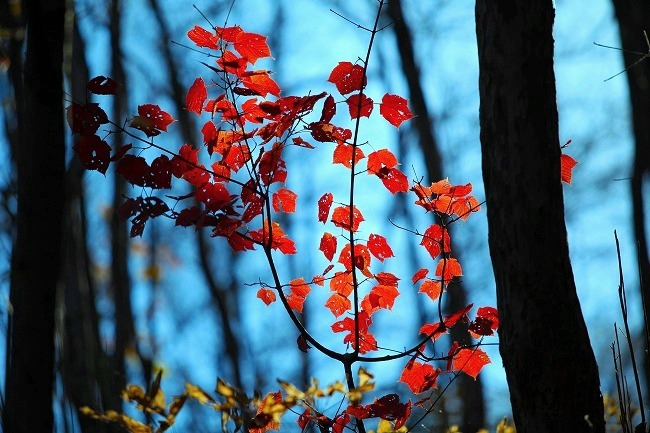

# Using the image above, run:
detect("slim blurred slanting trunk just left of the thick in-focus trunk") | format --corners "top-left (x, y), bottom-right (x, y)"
top-left (387, 0), bottom-right (485, 433)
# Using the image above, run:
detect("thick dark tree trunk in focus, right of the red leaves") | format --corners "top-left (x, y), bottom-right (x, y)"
top-left (476, 0), bottom-right (605, 433)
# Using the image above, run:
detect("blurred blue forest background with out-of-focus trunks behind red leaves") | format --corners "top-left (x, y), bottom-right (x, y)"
top-left (0, 0), bottom-right (650, 433)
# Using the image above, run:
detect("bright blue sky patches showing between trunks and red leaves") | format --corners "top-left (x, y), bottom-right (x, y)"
top-left (2, 0), bottom-right (643, 428)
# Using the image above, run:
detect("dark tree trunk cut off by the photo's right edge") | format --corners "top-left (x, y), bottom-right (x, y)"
top-left (613, 0), bottom-right (650, 397)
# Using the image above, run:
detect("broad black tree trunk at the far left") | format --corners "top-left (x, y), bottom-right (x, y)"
top-left (3, 0), bottom-right (65, 433)
